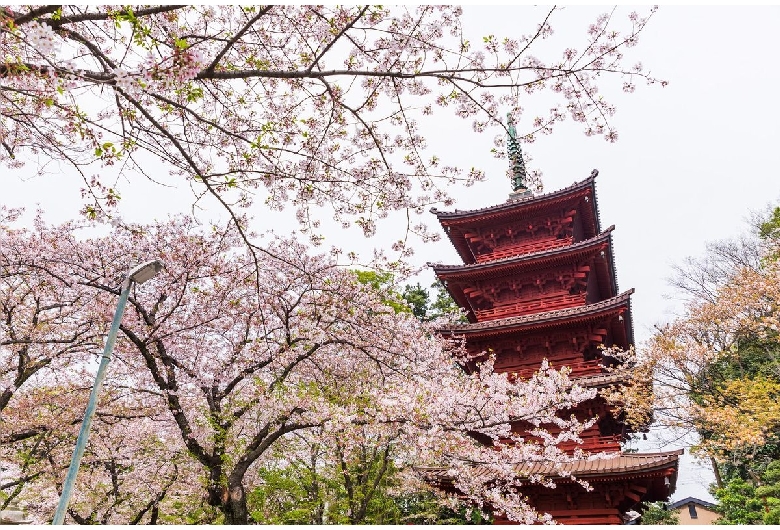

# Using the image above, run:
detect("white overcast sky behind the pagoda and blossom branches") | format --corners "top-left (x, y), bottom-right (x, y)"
top-left (6, 6), bottom-right (780, 500)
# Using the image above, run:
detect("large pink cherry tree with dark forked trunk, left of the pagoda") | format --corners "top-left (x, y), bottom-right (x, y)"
top-left (0, 212), bottom-right (593, 523)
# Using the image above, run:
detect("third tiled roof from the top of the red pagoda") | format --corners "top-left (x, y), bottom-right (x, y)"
top-left (438, 289), bottom-right (634, 343)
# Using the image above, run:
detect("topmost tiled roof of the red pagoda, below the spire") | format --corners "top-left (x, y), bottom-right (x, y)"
top-left (430, 172), bottom-right (601, 228)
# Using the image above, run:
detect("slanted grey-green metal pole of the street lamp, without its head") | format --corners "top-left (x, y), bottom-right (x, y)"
top-left (51, 276), bottom-right (133, 524)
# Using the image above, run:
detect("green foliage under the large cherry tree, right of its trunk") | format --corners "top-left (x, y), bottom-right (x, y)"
top-left (248, 435), bottom-right (485, 524)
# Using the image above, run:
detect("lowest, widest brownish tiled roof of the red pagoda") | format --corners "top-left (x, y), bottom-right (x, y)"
top-left (417, 449), bottom-right (683, 484)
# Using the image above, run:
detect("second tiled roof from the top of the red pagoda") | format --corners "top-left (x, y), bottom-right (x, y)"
top-left (427, 225), bottom-right (615, 281)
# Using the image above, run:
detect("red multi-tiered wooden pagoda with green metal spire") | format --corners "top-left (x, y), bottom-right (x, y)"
top-left (431, 117), bottom-right (681, 524)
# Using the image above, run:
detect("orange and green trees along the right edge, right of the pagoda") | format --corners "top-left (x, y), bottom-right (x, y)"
top-left (644, 203), bottom-right (780, 524)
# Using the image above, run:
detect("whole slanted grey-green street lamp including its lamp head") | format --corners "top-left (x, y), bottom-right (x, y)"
top-left (51, 260), bottom-right (163, 524)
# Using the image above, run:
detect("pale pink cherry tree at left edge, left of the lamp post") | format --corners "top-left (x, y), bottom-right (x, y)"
top-left (0, 207), bottom-right (101, 443)
